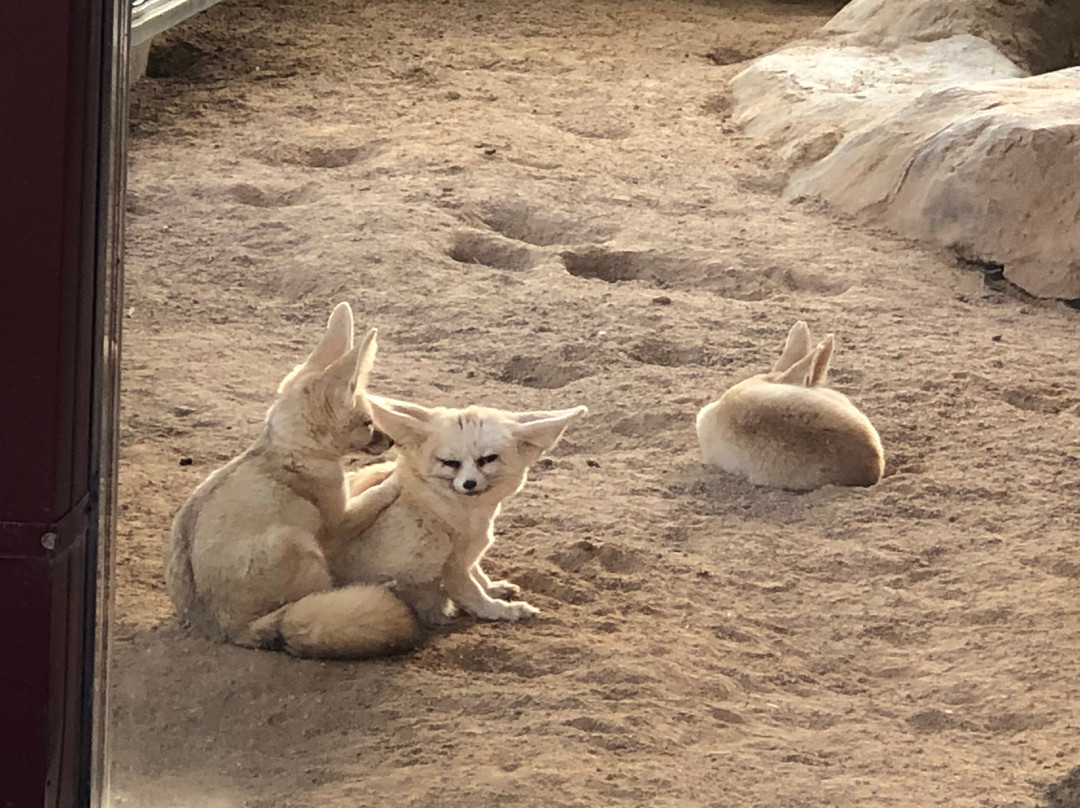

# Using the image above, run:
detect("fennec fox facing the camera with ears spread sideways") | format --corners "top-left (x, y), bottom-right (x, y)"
top-left (332, 396), bottom-right (588, 627)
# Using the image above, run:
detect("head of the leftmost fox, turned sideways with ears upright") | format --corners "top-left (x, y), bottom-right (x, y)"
top-left (267, 302), bottom-right (392, 458)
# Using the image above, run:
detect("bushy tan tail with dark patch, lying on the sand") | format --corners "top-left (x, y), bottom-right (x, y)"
top-left (246, 583), bottom-right (421, 659)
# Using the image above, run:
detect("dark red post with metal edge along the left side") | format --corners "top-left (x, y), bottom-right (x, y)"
top-left (0, 0), bottom-right (127, 808)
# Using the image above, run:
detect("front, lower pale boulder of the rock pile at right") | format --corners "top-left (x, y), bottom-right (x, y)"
top-left (785, 68), bottom-right (1080, 298)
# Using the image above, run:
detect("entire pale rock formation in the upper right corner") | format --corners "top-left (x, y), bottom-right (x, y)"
top-left (731, 0), bottom-right (1080, 298)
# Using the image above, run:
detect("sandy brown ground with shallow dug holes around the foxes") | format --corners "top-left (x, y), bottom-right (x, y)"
top-left (112, 0), bottom-right (1080, 808)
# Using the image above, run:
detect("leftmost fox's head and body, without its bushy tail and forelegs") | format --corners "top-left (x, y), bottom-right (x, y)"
top-left (165, 304), bottom-right (406, 645)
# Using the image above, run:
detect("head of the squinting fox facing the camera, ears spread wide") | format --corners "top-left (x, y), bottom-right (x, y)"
top-left (370, 396), bottom-right (586, 501)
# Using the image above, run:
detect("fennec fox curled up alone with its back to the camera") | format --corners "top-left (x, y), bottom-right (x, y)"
top-left (697, 320), bottom-right (885, 490)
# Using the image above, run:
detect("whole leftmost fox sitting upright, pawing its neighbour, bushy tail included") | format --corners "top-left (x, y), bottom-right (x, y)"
top-left (165, 302), bottom-right (419, 657)
